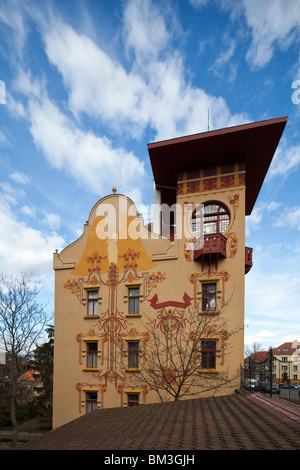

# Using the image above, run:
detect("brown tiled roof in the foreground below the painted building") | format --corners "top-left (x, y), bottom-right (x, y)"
top-left (18, 393), bottom-right (300, 454)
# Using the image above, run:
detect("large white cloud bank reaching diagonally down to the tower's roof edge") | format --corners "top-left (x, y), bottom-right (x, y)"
top-left (37, 1), bottom-right (249, 139)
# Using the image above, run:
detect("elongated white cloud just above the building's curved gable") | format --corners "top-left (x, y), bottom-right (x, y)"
top-left (25, 92), bottom-right (145, 194)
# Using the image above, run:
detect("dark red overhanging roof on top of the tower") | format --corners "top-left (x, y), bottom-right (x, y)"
top-left (148, 116), bottom-right (287, 215)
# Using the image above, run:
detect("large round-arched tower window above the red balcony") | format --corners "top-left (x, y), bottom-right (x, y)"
top-left (191, 202), bottom-right (230, 237)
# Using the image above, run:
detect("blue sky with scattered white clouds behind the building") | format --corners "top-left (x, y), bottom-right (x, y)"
top-left (0, 0), bottom-right (300, 349)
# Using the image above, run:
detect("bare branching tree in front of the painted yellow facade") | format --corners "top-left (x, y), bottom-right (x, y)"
top-left (116, 298), bottom-right (240, 401)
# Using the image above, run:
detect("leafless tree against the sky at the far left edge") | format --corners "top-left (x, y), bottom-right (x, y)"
top-left (0, 273), bottom-right (50, 446)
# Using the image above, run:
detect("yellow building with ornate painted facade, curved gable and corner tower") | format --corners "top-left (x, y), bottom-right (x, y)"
top-left (53, 118), bottom-right (287, 427)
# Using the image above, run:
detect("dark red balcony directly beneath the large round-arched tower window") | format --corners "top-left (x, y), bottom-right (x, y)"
top-left (194, 233), bottom-right (227, 271)
